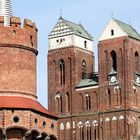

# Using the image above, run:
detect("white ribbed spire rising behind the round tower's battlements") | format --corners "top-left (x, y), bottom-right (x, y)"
top-left (0, 0), bottom-right (12, 26)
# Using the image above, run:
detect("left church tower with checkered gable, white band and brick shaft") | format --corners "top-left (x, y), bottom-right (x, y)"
top-left (48, 17), bottom-right (94, 140)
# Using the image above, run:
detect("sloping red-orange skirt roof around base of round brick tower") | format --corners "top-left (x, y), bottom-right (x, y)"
top-left (0, 96), bottom-right (57, 118)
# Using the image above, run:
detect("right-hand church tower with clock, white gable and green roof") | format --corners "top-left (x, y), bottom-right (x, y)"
top-left (98, 18), bottom-right (140, 140)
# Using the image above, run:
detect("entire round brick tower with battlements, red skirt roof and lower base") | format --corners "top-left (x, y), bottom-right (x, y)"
top-left (0, 17), bottom-right (57, 140)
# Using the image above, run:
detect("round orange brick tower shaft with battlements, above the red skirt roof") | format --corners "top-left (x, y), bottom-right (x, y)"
top-left (0, 17), bottom-right (38, 98)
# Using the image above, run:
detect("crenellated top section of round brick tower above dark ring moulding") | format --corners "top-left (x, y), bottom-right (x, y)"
top-left (0, 16), bottom-right (37, 50)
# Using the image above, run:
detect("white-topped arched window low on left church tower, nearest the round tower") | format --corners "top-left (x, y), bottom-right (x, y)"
top-left (55, 92), bottom-right (63, 113)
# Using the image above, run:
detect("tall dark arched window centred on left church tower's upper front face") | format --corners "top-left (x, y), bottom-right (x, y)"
top-left (59, 59), bottom-right (65, 85)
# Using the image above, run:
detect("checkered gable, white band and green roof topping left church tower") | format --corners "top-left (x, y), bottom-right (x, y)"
top-left (48, 17), bottom-right (93, 51)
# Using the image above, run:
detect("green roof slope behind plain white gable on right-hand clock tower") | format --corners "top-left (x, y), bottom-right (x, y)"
top-left (114, 19), bottom-right (140, 40)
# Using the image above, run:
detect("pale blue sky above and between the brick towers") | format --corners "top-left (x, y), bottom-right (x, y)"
top-left (12, 0), bottom-right (140, 107)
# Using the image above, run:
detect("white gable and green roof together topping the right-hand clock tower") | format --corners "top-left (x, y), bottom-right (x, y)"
top-left (99, 18), bottom-right (140, 41)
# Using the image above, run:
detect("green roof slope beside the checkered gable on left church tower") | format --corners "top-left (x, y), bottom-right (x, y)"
top-left (60, 17), bottom-right (93, 40)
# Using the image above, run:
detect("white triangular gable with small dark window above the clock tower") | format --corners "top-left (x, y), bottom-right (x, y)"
top-left (99, 19), bottom-right (127, 41)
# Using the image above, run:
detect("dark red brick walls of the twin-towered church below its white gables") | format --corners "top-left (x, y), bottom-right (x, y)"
top-left (48, 33), bottom-right (140, 140)
